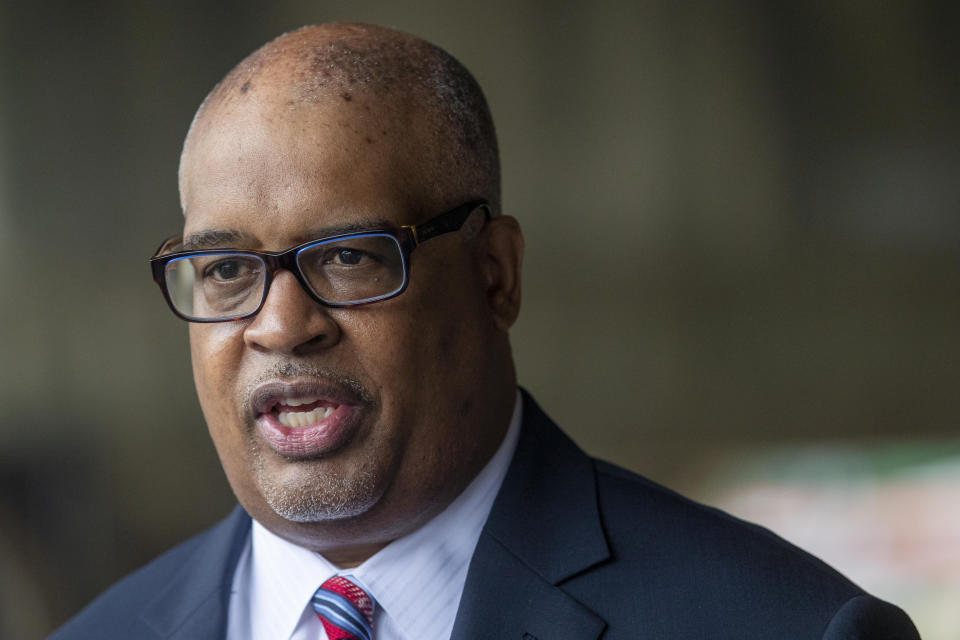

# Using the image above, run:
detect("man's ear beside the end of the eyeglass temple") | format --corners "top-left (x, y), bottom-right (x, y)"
top-left (479, 216), bottom-right (523, 332)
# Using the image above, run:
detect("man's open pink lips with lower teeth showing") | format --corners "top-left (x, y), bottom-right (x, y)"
top-left (249, 380), bottom-right (367, 459)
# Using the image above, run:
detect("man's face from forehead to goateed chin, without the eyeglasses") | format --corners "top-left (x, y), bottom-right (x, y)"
top-left (180, 86), bottom-right (513, 550)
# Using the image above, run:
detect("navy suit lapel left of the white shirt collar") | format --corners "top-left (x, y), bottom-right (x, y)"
top-left (142, 507), bottom-right (250, 640)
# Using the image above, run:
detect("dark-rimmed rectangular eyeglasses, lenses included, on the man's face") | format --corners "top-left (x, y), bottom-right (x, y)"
top-left (150, 200), bottom-right (490, 322)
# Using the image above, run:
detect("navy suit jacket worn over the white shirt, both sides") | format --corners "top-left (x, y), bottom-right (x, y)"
top-left (52, 394), bottom-right (919, 640)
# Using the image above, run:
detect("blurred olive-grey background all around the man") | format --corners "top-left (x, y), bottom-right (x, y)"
top-left (0, 0), bottom-right (960, 640)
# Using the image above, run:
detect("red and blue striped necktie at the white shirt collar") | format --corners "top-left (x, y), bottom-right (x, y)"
top-left (311, 576), bottom-right (374, 640)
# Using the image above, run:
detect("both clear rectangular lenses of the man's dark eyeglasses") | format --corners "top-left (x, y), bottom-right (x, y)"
top-left (165, 233), bottom-right (404, 320)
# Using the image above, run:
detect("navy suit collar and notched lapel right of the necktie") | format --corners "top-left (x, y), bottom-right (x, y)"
top-left (452, 393), bottom-right (610, 640)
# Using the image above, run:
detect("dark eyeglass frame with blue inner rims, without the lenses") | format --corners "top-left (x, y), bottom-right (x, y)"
top-left (150, 200), bottom-right (493, 323)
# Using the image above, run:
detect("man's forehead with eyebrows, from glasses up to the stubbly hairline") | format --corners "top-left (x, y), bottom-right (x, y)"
top-left (180, 85), bottom-right (445, 250)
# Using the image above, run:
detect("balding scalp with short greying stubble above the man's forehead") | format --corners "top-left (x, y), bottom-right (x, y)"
top-left (184, 24), bottom-right (500, 213)
